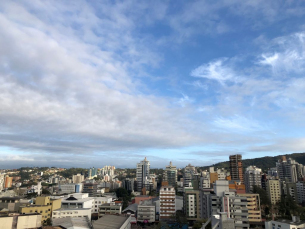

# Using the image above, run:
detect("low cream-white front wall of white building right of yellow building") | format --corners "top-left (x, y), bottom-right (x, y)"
top-left (52, 208), bottom-right (91, 220)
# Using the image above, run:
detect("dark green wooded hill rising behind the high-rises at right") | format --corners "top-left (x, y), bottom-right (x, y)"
top-left (199, 153), bottom-right (305, 172)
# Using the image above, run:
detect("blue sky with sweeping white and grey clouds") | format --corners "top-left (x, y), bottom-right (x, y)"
top-left (0, 0), bottom-right (305, 169)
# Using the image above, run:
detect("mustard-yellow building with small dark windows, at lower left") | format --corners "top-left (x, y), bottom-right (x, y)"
top-left (19, 196), bottom-right (61, 222)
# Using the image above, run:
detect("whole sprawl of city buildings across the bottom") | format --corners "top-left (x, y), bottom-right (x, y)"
top-left (0, 154), bottom-right (305, 229)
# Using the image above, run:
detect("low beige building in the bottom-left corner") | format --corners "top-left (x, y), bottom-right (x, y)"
top-left (0, 213), bottom-right (42, 229)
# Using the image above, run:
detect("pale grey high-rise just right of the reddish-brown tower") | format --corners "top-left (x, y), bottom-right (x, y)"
top-left (244, 166), bottom-right (262, 193)
